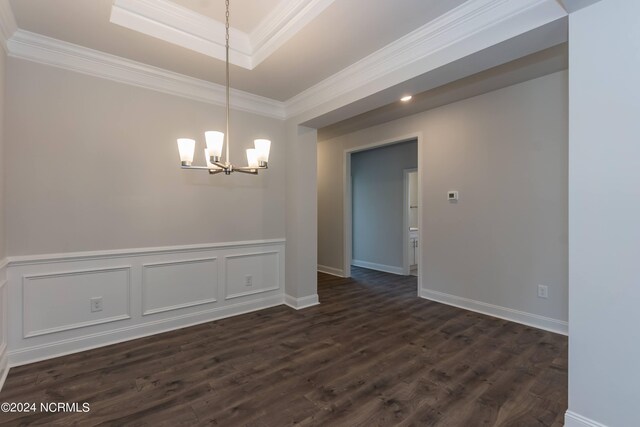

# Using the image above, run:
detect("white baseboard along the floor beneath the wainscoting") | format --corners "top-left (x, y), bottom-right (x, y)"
top-left (9, 295), bottom-right (282, 367)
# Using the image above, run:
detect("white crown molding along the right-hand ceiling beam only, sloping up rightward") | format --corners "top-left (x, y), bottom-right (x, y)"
top-left (285, 0), bottom-right (566, 117)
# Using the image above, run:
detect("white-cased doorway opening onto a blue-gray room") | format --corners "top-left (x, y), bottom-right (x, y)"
top-left (343, 134), bottom-right (421, 294)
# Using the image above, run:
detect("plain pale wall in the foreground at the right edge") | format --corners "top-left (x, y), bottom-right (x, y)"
top-left (566, 0), bottom-right (640, 427)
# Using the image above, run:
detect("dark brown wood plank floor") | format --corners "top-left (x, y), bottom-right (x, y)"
top-left (0, 268), bottom-right (567, 427)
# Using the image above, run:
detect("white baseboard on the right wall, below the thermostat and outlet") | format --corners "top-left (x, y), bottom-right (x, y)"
top-left (419, 289), bottom-right (569, 335)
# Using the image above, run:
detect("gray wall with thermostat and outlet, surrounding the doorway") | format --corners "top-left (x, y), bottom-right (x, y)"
top-left (318, 71), bottom-right (568, 321)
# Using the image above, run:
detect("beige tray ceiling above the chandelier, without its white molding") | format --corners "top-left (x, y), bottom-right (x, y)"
top-left (10, 0), bottom-right (465, 101)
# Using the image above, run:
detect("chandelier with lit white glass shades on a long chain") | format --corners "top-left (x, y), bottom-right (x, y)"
top-left (178, 0), bottom-right (271, 175)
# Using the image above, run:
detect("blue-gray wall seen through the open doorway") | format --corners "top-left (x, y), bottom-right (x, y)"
top-left (351, 141), bottom-right (418, 269)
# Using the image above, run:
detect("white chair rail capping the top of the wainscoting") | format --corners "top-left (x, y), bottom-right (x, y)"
top-left (7, 238), bottom-right (286, 267)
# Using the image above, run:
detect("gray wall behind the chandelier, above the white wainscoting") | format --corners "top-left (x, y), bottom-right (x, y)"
top-left (5, 58), bottom-right (286, 256)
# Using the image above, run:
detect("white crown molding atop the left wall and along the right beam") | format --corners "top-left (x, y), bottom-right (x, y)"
top-left (0, 0), bottom-right (567, 120)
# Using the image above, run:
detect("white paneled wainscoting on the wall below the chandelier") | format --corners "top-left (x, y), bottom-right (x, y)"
top-left (5, 239), bottom-right (285, 371)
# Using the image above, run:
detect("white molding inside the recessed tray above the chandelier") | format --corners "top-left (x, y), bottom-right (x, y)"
top-left (111, 0), bottom-right (335, 70)
